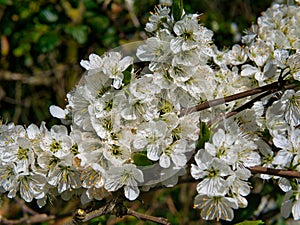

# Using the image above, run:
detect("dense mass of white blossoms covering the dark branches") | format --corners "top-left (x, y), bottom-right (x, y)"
top-left (0, 0), bottom-right (300, 221)
